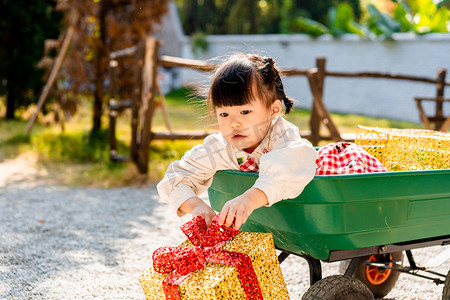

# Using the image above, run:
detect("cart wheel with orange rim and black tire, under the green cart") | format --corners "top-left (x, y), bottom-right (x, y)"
top-left (353, 251), bottom-right (403, 298)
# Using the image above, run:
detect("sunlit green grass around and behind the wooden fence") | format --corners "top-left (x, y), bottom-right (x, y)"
top-left (0, 89), bottom-right (422, 187)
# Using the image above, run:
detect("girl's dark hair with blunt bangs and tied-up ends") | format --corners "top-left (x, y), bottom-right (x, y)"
top-left (208, 54), bottom-right (294, 114)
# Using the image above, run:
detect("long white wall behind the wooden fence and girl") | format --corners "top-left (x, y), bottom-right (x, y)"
top-left (177, 34), bottom-right (450, 122)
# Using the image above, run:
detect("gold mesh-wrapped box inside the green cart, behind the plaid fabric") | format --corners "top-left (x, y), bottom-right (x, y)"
top-left (355, 126), bottom-right (450, 171)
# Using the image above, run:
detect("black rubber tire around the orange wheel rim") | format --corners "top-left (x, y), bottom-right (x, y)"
top-left (353, 252), bottom-right (403, 298)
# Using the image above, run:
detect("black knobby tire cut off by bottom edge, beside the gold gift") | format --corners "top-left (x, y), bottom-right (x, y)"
top-left (302, 275), bottom-right (375, 300)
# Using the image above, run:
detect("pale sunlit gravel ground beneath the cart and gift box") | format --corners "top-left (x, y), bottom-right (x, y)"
top-left (0, 184), bottom-right (450, 300)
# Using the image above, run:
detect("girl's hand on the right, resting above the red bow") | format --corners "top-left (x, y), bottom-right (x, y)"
top-left (219, 188), bottom-right (269, 230)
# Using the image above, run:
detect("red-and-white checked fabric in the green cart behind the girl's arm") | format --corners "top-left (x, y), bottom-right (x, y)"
top-left (316, 142), bottom-right (387, 175)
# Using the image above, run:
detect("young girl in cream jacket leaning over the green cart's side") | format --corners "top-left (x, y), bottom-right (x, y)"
top-left (157, 55), bottom-right (317, 229)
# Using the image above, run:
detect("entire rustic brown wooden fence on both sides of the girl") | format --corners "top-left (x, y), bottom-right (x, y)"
top-left (109, 38), bottom-right (450, 173)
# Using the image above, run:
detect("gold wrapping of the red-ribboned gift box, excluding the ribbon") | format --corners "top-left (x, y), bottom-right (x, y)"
top-left (139, 232), bottom-right (289, 300)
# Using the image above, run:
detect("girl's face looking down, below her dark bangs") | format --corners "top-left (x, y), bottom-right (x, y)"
top-left (216, 99), bottom-right (281, 150)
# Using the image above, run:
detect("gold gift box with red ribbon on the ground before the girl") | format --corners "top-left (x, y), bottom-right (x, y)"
top-left (139, 217), bottom-right (289, 300)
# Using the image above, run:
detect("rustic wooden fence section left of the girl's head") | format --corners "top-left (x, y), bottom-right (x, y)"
top-left (108, 38), bottom-right (214, 174)
